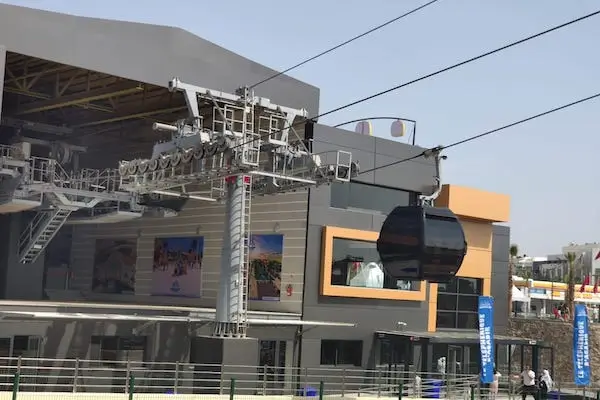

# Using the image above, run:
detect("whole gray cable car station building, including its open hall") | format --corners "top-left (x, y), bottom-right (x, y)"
top-left (0, 5), bottom-right (548, 384)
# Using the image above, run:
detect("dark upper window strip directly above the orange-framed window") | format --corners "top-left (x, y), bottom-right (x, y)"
top-left (331, 182), bottom-right (411, 214)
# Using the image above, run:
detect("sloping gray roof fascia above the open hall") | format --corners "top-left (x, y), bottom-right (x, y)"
top-left (0, 4), bottom-right (319, 115)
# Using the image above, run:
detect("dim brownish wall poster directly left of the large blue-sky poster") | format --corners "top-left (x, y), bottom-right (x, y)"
top-left (92, 238), bottom-right (137, 294)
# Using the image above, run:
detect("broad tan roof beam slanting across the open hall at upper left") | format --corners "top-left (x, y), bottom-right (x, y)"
top-left (17, 82), bottom-right (144, 115)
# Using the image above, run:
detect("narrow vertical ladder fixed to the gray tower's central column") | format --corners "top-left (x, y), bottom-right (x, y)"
top-left (236, 175), bottom-right (252, 337)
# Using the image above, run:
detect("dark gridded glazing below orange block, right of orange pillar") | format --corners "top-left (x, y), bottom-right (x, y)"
top-left (437, 278), bottom-right (483, 329)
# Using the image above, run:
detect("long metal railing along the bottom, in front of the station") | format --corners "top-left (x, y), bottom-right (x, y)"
top-left (0, 358), bottom-right (478, 399)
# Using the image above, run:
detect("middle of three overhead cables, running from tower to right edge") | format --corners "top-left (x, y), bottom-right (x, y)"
top-left (231, 10), bottom-right (600, 153)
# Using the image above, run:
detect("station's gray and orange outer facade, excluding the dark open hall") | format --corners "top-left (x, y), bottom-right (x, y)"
top-left (0, 5), bottom-right (510, 384)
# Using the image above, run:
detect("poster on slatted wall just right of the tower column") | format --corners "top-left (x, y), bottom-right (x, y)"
top-left (248, 235), bottom-right (283, 301)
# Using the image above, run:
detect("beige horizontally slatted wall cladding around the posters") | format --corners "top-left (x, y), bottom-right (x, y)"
top-left (72, 192), bottom-right (308, 313)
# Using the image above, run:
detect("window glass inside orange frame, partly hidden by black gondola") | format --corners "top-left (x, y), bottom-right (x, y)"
top-left (331, 239), bottom-right (419, 290)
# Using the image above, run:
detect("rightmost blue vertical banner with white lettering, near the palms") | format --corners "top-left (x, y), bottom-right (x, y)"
top-left (573, 304), bottom-right (590, 386)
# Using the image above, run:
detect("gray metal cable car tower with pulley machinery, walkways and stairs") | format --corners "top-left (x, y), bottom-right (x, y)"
top-left (0, 76), bottom-right (358, 337)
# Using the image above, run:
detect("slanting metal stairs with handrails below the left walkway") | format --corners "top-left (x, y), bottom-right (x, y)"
top-left (19, 207), bottom-right (73, 264)
